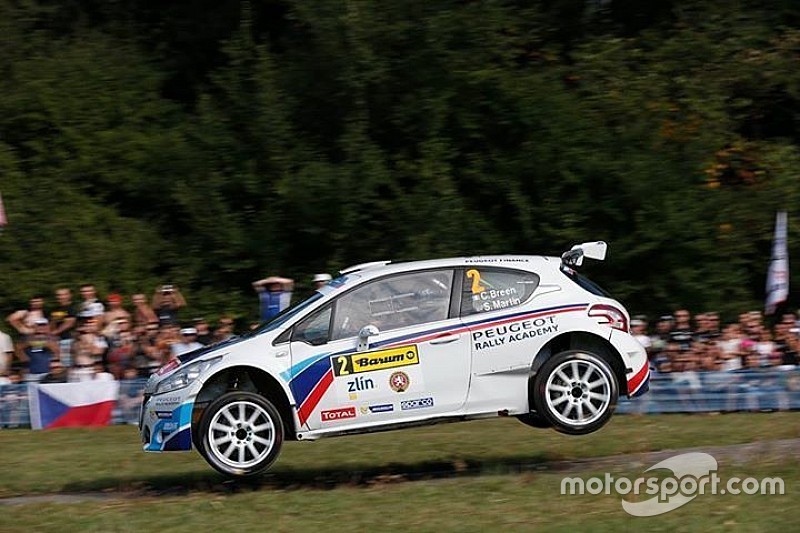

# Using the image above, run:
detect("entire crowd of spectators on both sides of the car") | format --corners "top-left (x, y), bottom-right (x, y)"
top-left (0, 274), bottom-right (800, 385)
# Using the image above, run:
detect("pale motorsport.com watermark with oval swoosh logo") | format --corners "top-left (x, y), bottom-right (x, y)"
top-left (561, 452), bottom-right (785, 516)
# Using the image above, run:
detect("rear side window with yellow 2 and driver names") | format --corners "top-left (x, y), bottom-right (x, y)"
top-left (461, 267), bottom-right (539, 316)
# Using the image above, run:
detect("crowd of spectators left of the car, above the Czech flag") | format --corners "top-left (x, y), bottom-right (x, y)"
top-left (0, 284), bottom-right (241, 385)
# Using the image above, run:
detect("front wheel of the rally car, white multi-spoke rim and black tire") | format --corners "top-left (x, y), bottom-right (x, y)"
top-left (197, 392), bottom-right (283, 477)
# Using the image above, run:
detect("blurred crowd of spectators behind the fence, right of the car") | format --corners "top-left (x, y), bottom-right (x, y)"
top-left (631, 309), bottom-right (800, 374)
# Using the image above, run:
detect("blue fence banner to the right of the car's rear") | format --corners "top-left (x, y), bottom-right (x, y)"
top-left (617, 367), bottom-right (800, 414)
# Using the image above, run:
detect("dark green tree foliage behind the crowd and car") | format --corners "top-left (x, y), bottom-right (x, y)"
top-left (0, 0), bottom-right (800, 317)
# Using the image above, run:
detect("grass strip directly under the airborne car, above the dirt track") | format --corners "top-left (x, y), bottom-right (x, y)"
top-left (0, 413), bottom-right (800, 496)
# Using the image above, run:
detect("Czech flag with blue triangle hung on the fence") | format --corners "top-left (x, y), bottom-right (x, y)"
top-left (28, 381), bottom-right (119, 429)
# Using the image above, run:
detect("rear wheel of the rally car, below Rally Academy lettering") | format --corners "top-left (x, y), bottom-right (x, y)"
top-left (533, 350), bottom-right (619, 435)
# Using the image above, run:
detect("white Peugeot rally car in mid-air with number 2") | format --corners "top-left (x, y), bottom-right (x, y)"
top-left (139, 242), bottom-right (649, 476)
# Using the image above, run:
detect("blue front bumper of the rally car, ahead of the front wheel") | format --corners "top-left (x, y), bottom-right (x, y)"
top-left (139, 391), bottom-right (194, 452)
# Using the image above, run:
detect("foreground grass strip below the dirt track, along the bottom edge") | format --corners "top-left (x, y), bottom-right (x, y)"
top-left (0, 459), bottom-right (800, 533)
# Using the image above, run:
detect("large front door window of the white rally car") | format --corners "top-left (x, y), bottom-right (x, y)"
top-left (331, 270), bottom-right (453, 340)
